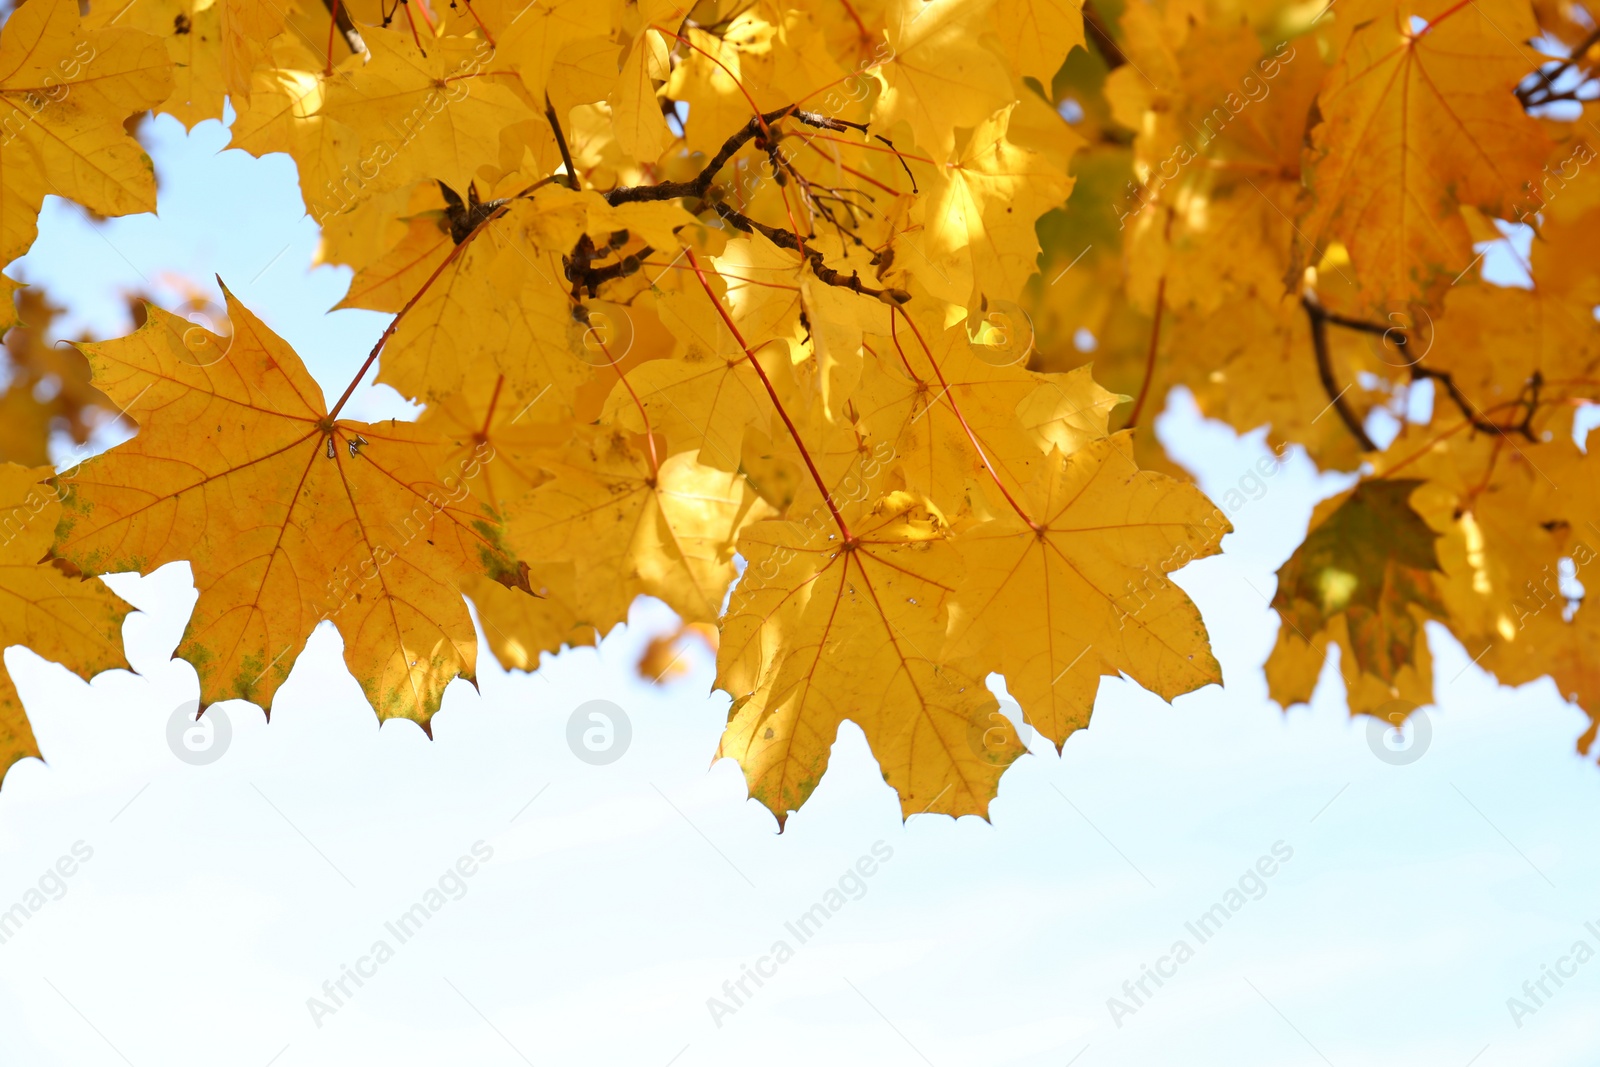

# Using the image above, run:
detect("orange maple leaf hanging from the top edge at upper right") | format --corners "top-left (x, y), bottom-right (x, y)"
top-left (1304, 0), bottom-right (1550, 312)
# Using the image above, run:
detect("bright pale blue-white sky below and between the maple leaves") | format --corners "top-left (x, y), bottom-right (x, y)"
top-left (0, 108), bottom-right (1600, 1067)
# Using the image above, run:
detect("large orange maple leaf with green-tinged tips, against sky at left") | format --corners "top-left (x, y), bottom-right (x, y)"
top-left (56, 287), bottom-right (517, 725)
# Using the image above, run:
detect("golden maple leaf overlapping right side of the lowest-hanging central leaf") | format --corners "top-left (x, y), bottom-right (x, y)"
top-left (952, 434), bottom-right (1232, 747)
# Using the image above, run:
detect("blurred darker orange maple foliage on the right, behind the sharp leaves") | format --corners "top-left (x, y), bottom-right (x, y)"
top-left (1035, 0), bottom-right (1600, 752)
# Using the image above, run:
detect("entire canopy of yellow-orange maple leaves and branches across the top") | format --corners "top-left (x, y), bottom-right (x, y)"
top-left (0, 0), bottom-right (1600, 821)
